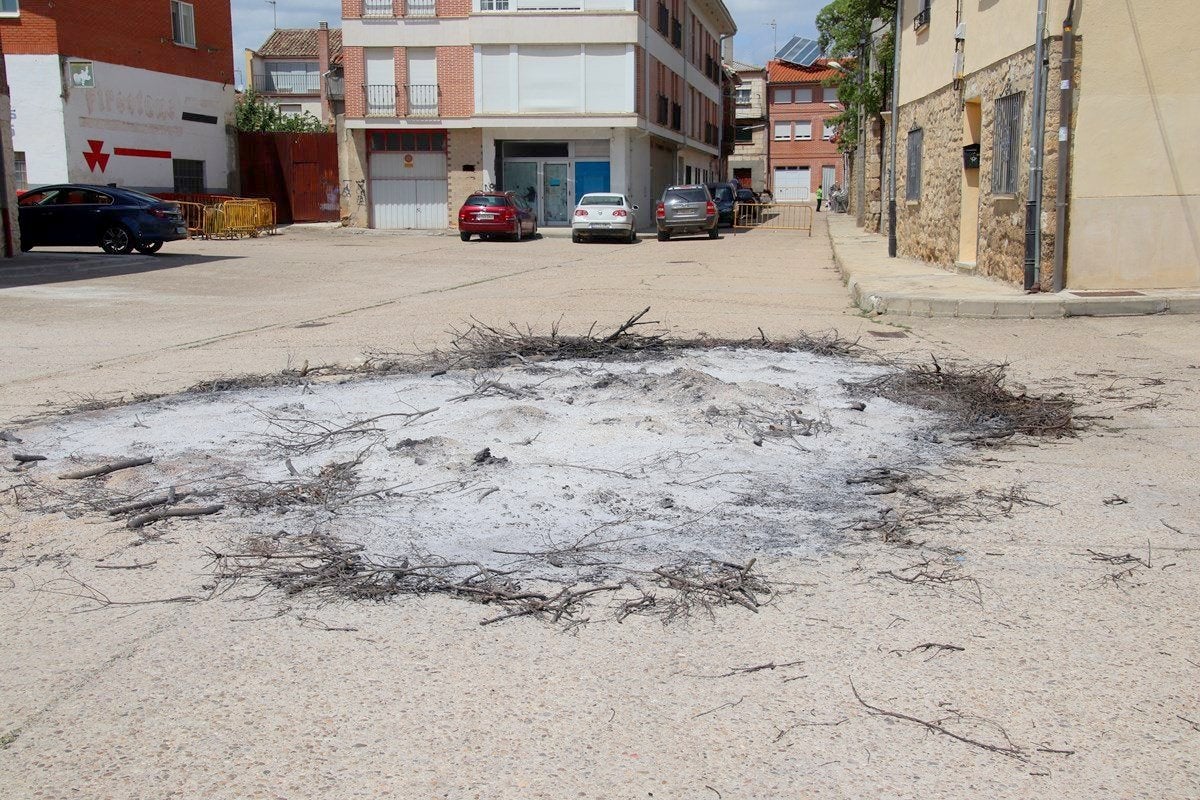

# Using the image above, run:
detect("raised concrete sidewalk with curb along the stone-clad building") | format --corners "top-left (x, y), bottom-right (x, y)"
top-left (826, 213), bottom-right (1200, 319)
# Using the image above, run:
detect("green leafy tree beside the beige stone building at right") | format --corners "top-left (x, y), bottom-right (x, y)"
top-left (817, 0), bottom-right (896, 150)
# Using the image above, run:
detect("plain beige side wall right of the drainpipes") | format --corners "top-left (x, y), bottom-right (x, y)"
top-left (1067, 0), bottom-right (1200, 288)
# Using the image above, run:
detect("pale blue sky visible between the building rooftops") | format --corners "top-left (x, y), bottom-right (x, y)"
top-left (226, 0), bottom-right (828, 82)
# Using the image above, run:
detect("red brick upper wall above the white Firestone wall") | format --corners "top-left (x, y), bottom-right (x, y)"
top-left (0, 0), bottom-right (234, 83)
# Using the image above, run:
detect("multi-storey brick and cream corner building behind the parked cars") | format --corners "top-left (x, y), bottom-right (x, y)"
top-left (338, 0), bottom-right (736, 228)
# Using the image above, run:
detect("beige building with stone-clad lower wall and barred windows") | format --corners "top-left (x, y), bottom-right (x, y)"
top-left (896, 0), bottom-right (1200, 289)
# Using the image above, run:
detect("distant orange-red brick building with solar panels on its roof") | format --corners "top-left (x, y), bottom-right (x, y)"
top-left (767, 59), bottom-right (845, 203)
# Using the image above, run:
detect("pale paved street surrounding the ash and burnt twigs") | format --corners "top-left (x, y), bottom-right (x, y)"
top-left (0, 216), bottom-right (1200, 800)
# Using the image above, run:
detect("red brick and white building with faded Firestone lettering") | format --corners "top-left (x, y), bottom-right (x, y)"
top-left (0, 0), bottom-right (236, 192)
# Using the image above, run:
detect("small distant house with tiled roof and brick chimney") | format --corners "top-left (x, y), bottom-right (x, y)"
top-left (246, 23), bottom-right (344, 125)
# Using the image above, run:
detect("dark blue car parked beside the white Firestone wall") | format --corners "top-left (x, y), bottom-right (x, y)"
top-left (17, 184), bottom-right (187, 255)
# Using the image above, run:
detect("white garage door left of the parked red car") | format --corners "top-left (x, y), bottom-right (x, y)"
top-left (371, 152), bottom-right (449, 229)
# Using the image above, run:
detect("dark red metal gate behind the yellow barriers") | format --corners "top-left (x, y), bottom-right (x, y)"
top-left (238, 131), bottom-right (341, 223)
